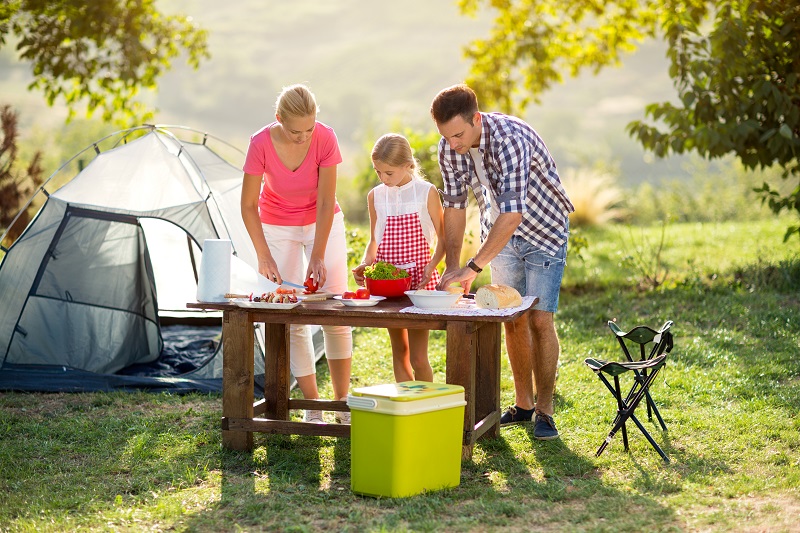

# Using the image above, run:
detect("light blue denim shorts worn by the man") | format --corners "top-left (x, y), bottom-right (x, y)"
top-left (492, 235), bottom-right (567, 313)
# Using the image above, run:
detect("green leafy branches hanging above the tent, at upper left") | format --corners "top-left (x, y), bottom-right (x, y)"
top-left (0, 0), bottom-right (209, 125)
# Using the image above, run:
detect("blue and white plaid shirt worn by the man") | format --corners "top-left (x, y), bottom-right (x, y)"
top-left (439, 113), bottom-right (575, 255)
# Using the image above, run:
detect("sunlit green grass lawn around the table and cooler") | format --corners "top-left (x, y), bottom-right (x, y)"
top-left (0, 220), bottom-right (800, 532)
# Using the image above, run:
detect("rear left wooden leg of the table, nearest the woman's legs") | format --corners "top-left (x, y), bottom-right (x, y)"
top-left (264, 324), bottom-right (291, 420)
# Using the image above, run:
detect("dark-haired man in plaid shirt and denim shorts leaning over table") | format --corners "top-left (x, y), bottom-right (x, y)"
top-left (431, 85), bottom-right (574, 440)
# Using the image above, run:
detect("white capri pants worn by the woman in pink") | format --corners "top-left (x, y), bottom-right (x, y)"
top-left (261, 211), bottom-right (353, 378)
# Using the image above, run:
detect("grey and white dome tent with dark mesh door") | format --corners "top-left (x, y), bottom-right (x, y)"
top-left (0, 125), bottom-right (320, 391)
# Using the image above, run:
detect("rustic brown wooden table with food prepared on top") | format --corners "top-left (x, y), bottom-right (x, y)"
top-left (187, 296), bottom-right (536, 458)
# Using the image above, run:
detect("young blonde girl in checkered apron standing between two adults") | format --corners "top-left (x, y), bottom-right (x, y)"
top-left (353, 133), bottom-right (444, 382)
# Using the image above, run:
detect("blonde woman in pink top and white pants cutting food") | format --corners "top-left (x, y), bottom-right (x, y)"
top-left (241, 85), bottom-right (353, 422)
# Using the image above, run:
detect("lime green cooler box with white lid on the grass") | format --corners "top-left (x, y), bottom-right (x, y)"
top-left (347, 381), bottom-right (466, 498)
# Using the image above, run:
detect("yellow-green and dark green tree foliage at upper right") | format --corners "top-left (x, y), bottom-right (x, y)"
top-left (460, 0), bottom-right (800, 239)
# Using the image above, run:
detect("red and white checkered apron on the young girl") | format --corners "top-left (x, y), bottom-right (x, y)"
top-left (376, 213), bottom-right (439, 290)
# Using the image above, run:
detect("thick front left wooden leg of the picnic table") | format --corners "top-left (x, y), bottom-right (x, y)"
top-left (222, 311), bottom-right (255, 451)
